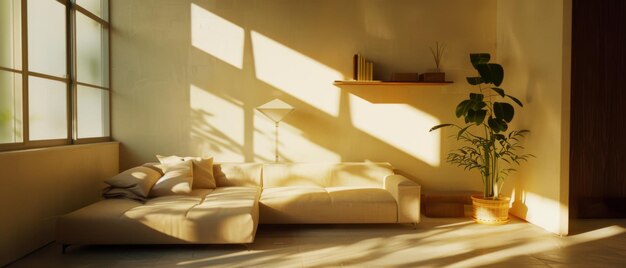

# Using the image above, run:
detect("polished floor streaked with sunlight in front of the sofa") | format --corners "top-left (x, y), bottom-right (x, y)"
top-left (9, 218), bottom-right (626, 268)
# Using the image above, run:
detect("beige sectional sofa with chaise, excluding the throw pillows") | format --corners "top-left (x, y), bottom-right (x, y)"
top-left (57, 163), bottom-right (420, 245)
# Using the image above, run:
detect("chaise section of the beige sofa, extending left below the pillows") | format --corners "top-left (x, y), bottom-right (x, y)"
top-left (57, 187), bottom-right (260, 244)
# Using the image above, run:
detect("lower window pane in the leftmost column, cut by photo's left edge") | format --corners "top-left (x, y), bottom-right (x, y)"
top-left (0, 71), bottom-right (23, 143)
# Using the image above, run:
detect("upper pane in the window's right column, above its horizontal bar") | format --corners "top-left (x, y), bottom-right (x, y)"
top-left (76, 12), bottom-right (109, 87)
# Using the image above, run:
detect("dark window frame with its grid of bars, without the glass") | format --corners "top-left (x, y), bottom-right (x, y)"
top-left (0, 0), bottom-right (112, 151)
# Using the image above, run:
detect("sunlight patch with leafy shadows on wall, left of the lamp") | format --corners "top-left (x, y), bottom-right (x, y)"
top-left (189, 85), bottom-right (244, 162)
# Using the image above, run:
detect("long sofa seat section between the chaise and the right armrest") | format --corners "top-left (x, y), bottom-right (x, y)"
top-left (259, 186), bottom-right (397, 224)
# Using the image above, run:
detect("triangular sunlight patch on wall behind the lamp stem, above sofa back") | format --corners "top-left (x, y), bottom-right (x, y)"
top-left (253, 112), bottom-right (341, 162)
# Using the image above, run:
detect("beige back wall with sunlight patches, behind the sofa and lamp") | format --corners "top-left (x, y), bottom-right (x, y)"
top-left (111, 0), bottom-right (496, 190)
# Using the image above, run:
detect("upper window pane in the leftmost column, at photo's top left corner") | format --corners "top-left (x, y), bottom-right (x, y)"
top-left (0, 0), bottom-right (22, 70)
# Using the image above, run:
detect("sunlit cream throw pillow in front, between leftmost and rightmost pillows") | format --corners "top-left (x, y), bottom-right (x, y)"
top-left (150, 156), bottom-right (193, 197)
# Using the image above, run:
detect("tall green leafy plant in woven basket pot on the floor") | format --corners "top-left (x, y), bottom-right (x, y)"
top-left (430, 53), bottom-right (532, 224)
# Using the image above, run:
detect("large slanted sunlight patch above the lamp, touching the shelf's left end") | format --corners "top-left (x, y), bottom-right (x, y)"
top-left (251, 31), bottom-right (343, 116)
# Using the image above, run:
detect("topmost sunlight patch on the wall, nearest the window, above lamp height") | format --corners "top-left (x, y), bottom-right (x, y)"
top-left (191, 4), bottom-right (244, 69)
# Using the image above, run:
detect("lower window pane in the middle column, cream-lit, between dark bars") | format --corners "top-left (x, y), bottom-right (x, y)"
top-left (28, 76), bottom-right (68, 140)
